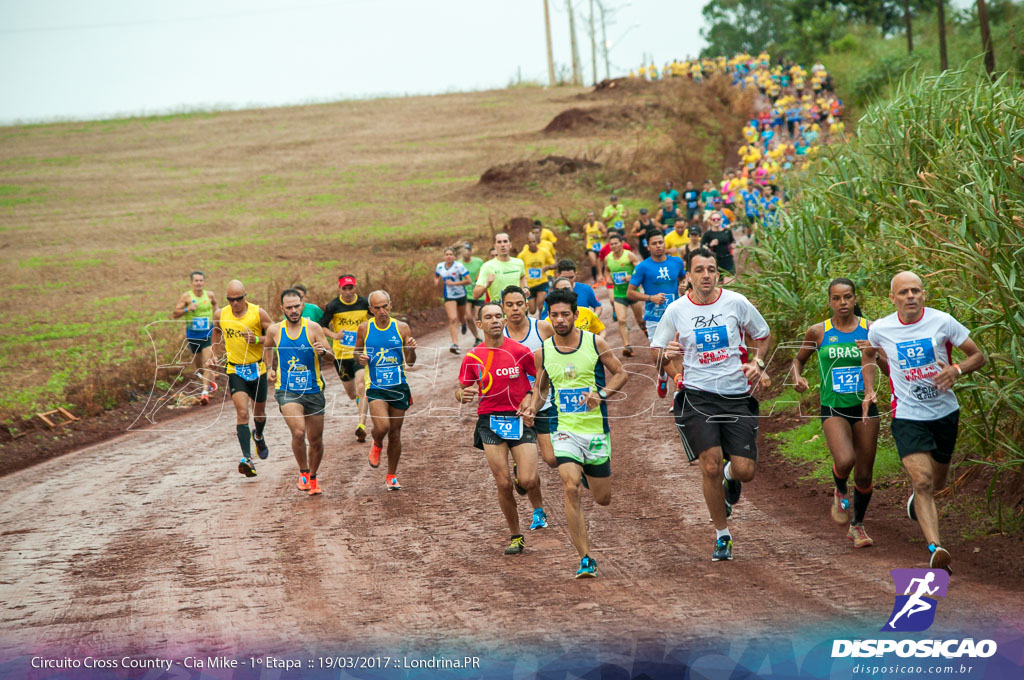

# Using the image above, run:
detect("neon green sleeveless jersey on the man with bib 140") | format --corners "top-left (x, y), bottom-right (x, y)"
top-left (542, 331), bottom-right (608, 434)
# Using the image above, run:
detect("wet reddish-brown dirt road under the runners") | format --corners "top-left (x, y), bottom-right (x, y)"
top-left (0, 301), bottom-right (1021, 655)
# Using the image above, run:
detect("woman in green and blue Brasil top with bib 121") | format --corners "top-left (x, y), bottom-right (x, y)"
top-left (792, 279), bottom-right (888, 548)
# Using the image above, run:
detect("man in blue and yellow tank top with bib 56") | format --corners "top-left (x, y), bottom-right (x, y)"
top-left (263, 288), bottom-right (332, 496)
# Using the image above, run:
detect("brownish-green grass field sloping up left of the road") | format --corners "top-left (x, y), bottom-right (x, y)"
top-left (0, 88), bottom-right (655, 422)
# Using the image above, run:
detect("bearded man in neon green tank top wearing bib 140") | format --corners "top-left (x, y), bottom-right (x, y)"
top-left (532, 289), bottom-right (628, 579)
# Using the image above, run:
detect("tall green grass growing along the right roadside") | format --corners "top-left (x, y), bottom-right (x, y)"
top-left (744, 62), bottom-right (1024, 483)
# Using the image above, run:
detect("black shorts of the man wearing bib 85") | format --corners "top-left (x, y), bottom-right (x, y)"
top-left (674, 388), bottom-right (759, 461)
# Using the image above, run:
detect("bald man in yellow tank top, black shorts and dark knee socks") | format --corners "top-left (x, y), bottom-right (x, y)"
top-left (207, 280), bottom-right (273, 477)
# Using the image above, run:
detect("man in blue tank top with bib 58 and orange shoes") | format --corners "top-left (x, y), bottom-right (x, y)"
top-left (355, 291), bottom-right (416, 491)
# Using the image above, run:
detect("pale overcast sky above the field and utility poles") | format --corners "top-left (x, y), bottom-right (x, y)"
top-left (0, 0), bottom-right (703, 123)
